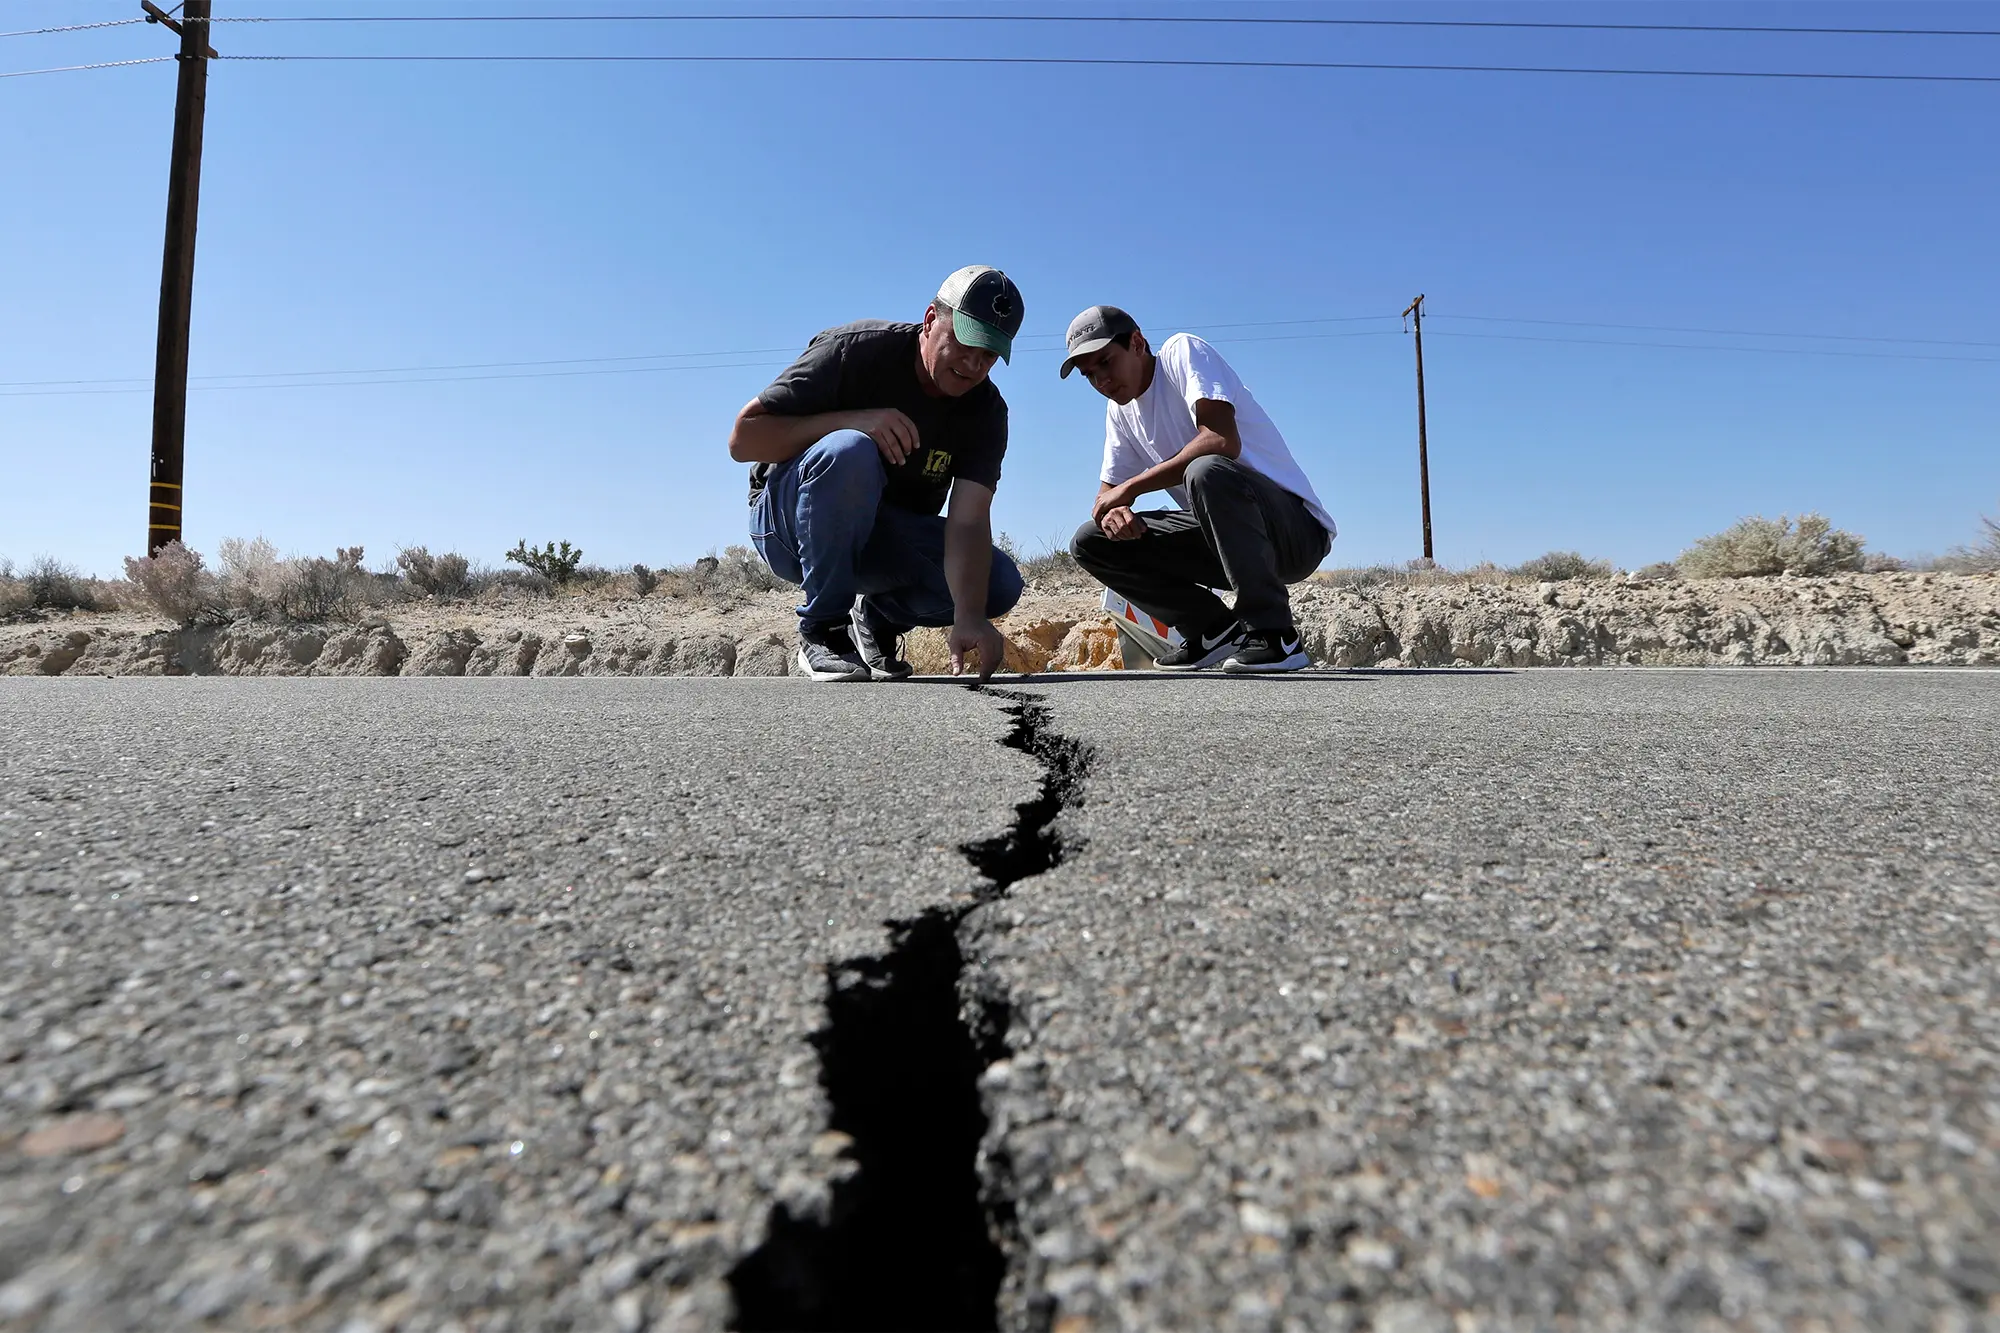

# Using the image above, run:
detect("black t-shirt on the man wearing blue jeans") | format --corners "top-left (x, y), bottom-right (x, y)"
top-left (750, 320), bottom-right (1006, 514)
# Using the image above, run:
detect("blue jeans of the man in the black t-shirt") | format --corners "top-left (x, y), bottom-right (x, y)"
top-left (750, 430), bottom-right (1020, 628)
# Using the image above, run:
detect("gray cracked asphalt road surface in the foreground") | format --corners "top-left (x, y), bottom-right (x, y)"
top-left (0, 671), bottom-right (2000, 1333)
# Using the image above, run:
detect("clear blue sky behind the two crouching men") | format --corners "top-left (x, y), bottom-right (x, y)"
top-left (0, 0), bottom-right (2000, 572)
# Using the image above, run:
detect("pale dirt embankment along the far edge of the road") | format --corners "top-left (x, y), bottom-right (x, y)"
top-left (0, 574), bottom-right (2000, 677)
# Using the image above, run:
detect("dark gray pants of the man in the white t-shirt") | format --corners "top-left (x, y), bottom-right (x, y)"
top-left (1070, 454), bottom-right (1334, 638)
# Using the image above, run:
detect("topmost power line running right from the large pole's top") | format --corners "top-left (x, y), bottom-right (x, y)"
top-left (199, 14), bottom-right (2000, 38)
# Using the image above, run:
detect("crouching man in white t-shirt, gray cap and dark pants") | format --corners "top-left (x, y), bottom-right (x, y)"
top-left (1062, 306), bottom-right (1334, 673)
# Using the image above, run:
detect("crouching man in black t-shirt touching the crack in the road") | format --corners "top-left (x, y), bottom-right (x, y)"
top-left (730, 264), bottom-right (1022, 681)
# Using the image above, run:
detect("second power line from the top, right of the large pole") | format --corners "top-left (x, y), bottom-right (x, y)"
top-left (199, 54), bottom-right (2000, 84)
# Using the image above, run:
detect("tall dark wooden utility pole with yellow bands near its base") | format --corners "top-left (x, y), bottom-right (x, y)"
top-left (140, 0), bottom-right (216, 554)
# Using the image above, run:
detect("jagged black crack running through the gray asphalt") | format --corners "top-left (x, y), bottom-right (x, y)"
top-left (728, 687), bottom-right (1092, 1333)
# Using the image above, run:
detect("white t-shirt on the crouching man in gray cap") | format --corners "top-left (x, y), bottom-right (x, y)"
top-left (1098, 334), bottom-right (1334, 534)
